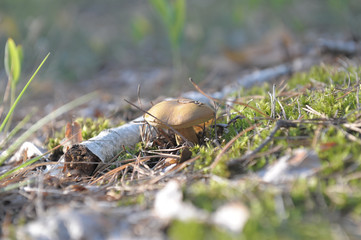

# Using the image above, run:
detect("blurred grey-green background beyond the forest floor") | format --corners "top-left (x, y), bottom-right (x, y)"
top-left (0, 0), bottom-right (361, 100)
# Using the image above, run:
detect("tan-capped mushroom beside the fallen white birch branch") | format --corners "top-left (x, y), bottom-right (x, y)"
top-left (144, 99), bottom-right (214, 144)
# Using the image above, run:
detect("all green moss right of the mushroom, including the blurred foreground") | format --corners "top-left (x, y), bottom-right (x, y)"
top-left (168, 66), bottom-right (361, 239)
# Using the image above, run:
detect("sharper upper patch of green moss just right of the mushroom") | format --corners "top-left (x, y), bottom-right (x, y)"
top-left (219, 66), bottom-right (359, 171)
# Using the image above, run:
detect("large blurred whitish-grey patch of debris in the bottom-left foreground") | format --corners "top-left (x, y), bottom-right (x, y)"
top-left (16, 202), bottom-right (164, 240)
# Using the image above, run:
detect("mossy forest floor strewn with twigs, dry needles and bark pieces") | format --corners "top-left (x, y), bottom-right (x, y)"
top-left (0, 32), bottom-right (361, 239)
